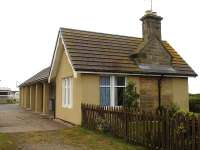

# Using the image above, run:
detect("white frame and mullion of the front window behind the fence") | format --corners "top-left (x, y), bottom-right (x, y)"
top-left (100, 75), bottom-right (127, 106)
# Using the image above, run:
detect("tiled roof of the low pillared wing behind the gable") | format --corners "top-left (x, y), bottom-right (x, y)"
top-left (20, 67), bottom-right (50, 86)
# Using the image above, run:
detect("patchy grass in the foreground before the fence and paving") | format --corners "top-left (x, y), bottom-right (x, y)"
top-left (0, 127), bottom-right (146, 150)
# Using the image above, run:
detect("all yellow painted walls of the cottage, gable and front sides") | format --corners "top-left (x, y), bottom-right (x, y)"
top-left (56, 48), bottom-right (188, 125)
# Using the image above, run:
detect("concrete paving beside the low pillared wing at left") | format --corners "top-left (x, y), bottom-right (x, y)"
top-left (0, 104), bottom-right (67, 133)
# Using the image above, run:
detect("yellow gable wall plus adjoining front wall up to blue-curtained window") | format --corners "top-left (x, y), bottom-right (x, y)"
top-left (56, 53), bottom-right (139, 125)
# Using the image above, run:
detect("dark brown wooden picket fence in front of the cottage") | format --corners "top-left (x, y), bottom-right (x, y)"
top-left (81, 104), bottom-right (200, 150)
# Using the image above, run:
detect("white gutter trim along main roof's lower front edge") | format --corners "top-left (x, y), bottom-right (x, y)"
top-left (76, 71), bottom-right (189, 78)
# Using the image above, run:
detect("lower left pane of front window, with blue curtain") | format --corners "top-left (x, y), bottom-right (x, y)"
top-left (100, 87), bottom-right (110, 106)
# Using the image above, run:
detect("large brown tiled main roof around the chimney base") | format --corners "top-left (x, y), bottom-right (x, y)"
top-left (60, 28), bottom-right (197, 76)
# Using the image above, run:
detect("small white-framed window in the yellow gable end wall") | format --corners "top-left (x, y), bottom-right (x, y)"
top-left (62, 78), bottom-right (72, 108)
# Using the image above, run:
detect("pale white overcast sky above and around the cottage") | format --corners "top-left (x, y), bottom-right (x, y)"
top-left (0, 0), bottom-right (200, 93)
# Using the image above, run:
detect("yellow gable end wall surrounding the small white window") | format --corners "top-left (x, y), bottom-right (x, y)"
top-left (56, 49), bottom-right (82, 124)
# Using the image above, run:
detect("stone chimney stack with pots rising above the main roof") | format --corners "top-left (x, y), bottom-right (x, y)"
top-left (140, 11), bottom-right (163, 41)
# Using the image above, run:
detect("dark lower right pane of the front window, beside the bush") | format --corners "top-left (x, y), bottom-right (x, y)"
top-left (115, 87), bottom-right (125, 106)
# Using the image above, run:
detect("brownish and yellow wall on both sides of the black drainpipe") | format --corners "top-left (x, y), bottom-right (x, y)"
top-left (140, 77), bottom-right (189, 111)
